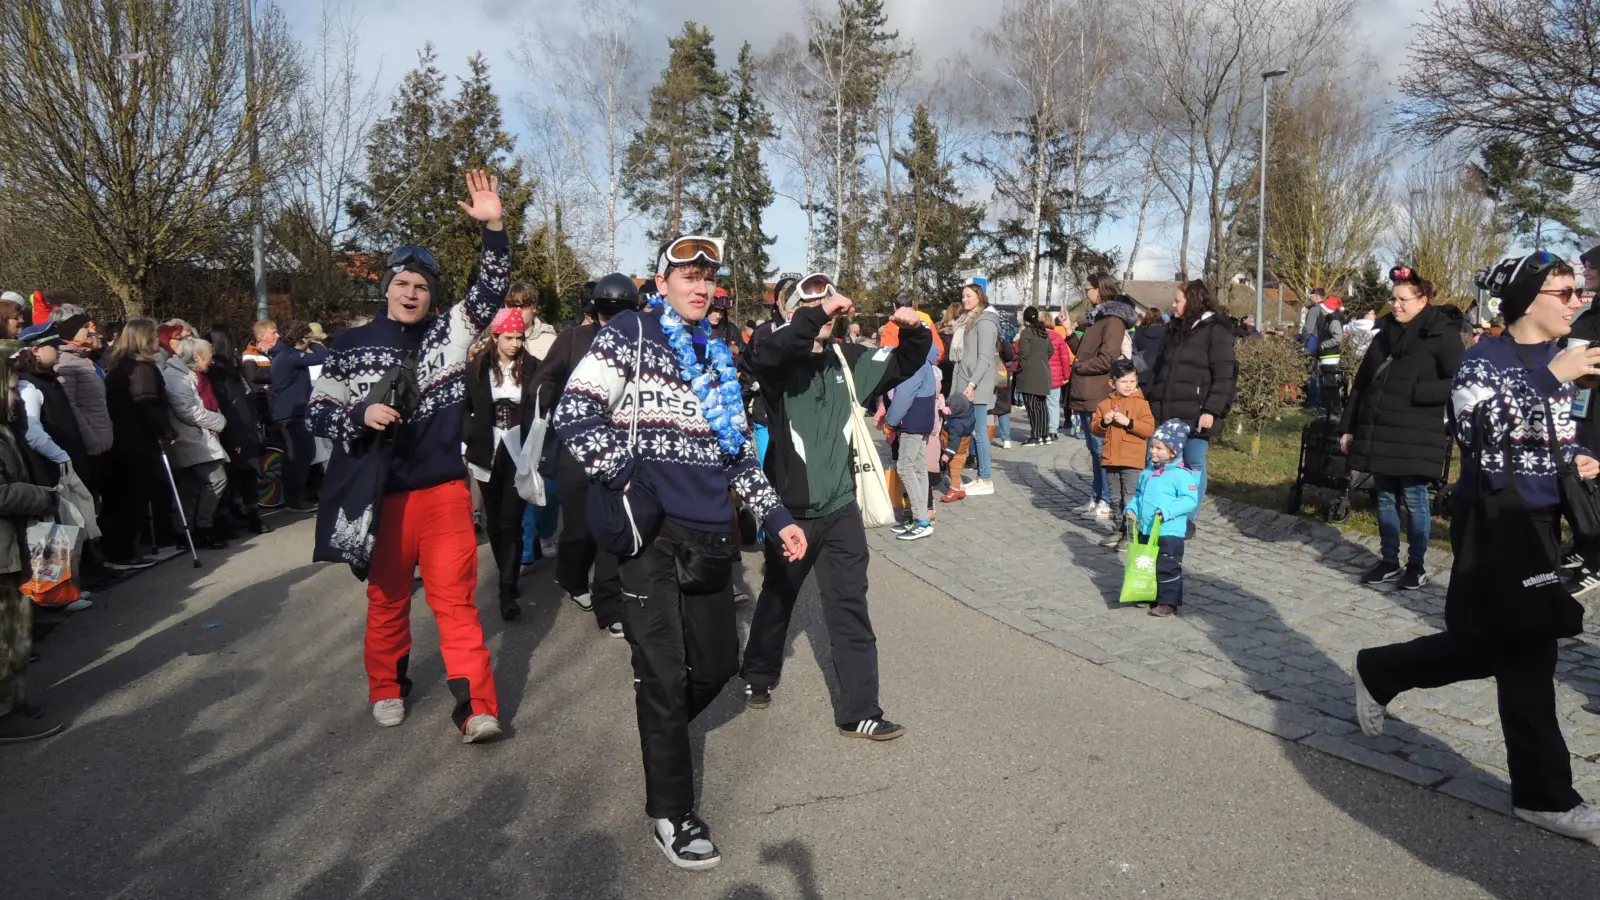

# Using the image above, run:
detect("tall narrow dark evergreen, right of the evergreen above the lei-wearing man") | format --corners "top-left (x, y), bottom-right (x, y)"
top-left (717, 42), bottom-right (774, 313)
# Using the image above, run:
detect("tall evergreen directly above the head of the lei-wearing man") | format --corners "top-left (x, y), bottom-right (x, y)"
top-left (624, 22), bottom-right (730, 243)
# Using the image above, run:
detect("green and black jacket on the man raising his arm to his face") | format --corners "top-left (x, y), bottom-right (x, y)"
top-left (744, 306), bottom-right (933, 519)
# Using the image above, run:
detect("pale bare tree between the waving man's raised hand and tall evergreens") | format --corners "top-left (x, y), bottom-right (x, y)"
top-left (514, 0), bottom-right (645, 271)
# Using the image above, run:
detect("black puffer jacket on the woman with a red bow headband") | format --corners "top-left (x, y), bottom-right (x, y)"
top-left (1339, 306), bottom-right (1466, 479)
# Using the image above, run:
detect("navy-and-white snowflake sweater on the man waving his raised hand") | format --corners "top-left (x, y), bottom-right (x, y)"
top-left (306, 222), bottom-right (510, 493)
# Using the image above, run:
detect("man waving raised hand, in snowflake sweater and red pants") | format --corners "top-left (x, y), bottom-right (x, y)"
top-left (306, 171), bottom-right (510, 743)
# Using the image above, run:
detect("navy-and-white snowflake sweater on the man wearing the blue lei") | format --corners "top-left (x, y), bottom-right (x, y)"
top-left (550, 304), bottom-right (794, 533)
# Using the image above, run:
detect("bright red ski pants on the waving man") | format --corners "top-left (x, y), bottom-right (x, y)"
top-left (366, 480), bottom-right (499, 727)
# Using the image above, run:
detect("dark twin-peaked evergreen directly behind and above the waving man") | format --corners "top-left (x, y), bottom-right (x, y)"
top-left (350, 43), bottom-right (531, 297)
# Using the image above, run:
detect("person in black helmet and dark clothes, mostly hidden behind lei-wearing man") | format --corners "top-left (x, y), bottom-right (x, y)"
top-left (533, 272), bottom-right (638, 637)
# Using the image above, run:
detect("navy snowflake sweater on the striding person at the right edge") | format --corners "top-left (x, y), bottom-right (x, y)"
top-left (1451, 333), bottom-right (1594, 509)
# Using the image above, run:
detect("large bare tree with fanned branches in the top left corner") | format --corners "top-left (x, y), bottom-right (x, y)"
top-left (0, 0), bottom-right (299, 315)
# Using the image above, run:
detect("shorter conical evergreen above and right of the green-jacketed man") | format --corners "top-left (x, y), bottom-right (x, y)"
top-left (885, 106), bottom-right (984, 299)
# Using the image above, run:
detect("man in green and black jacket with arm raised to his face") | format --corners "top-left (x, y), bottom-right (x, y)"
top-left (741, 275), bottom-right (933, 740)
